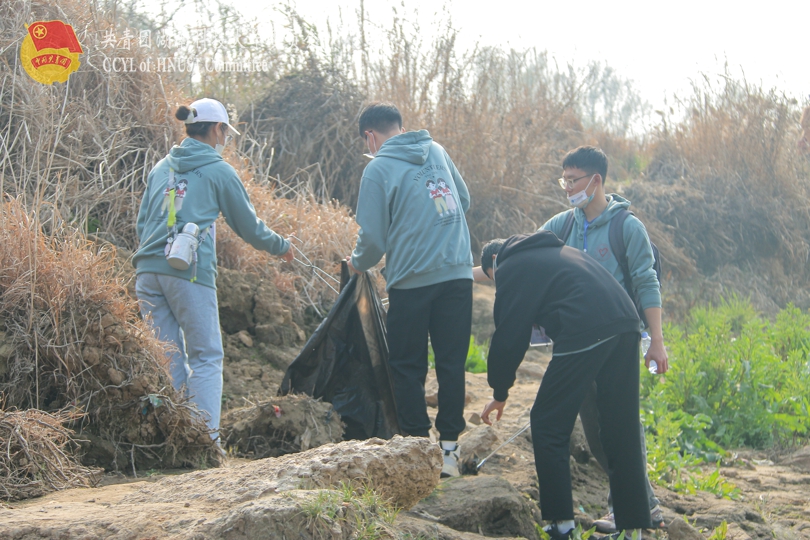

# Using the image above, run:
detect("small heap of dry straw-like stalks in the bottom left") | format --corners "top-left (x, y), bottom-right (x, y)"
top-left (0, 409), bottom-right (100, 501)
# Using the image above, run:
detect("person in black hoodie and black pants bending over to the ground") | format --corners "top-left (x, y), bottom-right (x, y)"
top-left (481, 231), bottom-right (651, 540)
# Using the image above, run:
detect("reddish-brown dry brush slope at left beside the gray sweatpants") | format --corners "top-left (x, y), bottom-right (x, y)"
top-left (0, 199), bottom-right (217, 472)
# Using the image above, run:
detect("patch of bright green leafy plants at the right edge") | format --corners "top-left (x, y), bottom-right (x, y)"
top-left (641, 297), bottom-right (810, 498)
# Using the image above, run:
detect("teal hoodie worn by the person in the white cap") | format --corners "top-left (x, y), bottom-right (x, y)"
top-left (132, 137), bottom-right (290, 289)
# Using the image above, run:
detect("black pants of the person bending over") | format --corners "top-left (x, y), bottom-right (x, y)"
top-left (531, 332), bottom-right (651, 530)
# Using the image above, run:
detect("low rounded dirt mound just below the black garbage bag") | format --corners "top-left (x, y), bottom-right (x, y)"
top-left (221, 395), bottom-right (343, 458)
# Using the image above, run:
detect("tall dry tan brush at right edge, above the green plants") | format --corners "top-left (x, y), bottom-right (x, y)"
top-left (626, 75), bottom-right (810, 316)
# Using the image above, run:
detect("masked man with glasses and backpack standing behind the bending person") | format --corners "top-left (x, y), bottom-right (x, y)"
top-left (540, 146), bottom-right (669, 533)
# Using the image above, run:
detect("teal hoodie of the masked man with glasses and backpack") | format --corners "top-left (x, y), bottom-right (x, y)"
top-left (540, 193), bottom-right (661, 309)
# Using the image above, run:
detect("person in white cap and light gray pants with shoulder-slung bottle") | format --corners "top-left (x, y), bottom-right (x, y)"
top-left (132, 98), bottom-right (293, 439)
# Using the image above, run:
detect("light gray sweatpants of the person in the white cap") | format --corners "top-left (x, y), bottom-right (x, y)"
top-left (135, 274), bottom-right (224, 439)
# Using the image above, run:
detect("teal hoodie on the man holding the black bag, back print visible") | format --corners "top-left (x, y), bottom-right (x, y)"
top-left (352, 130), bottom-right (472, 290)
